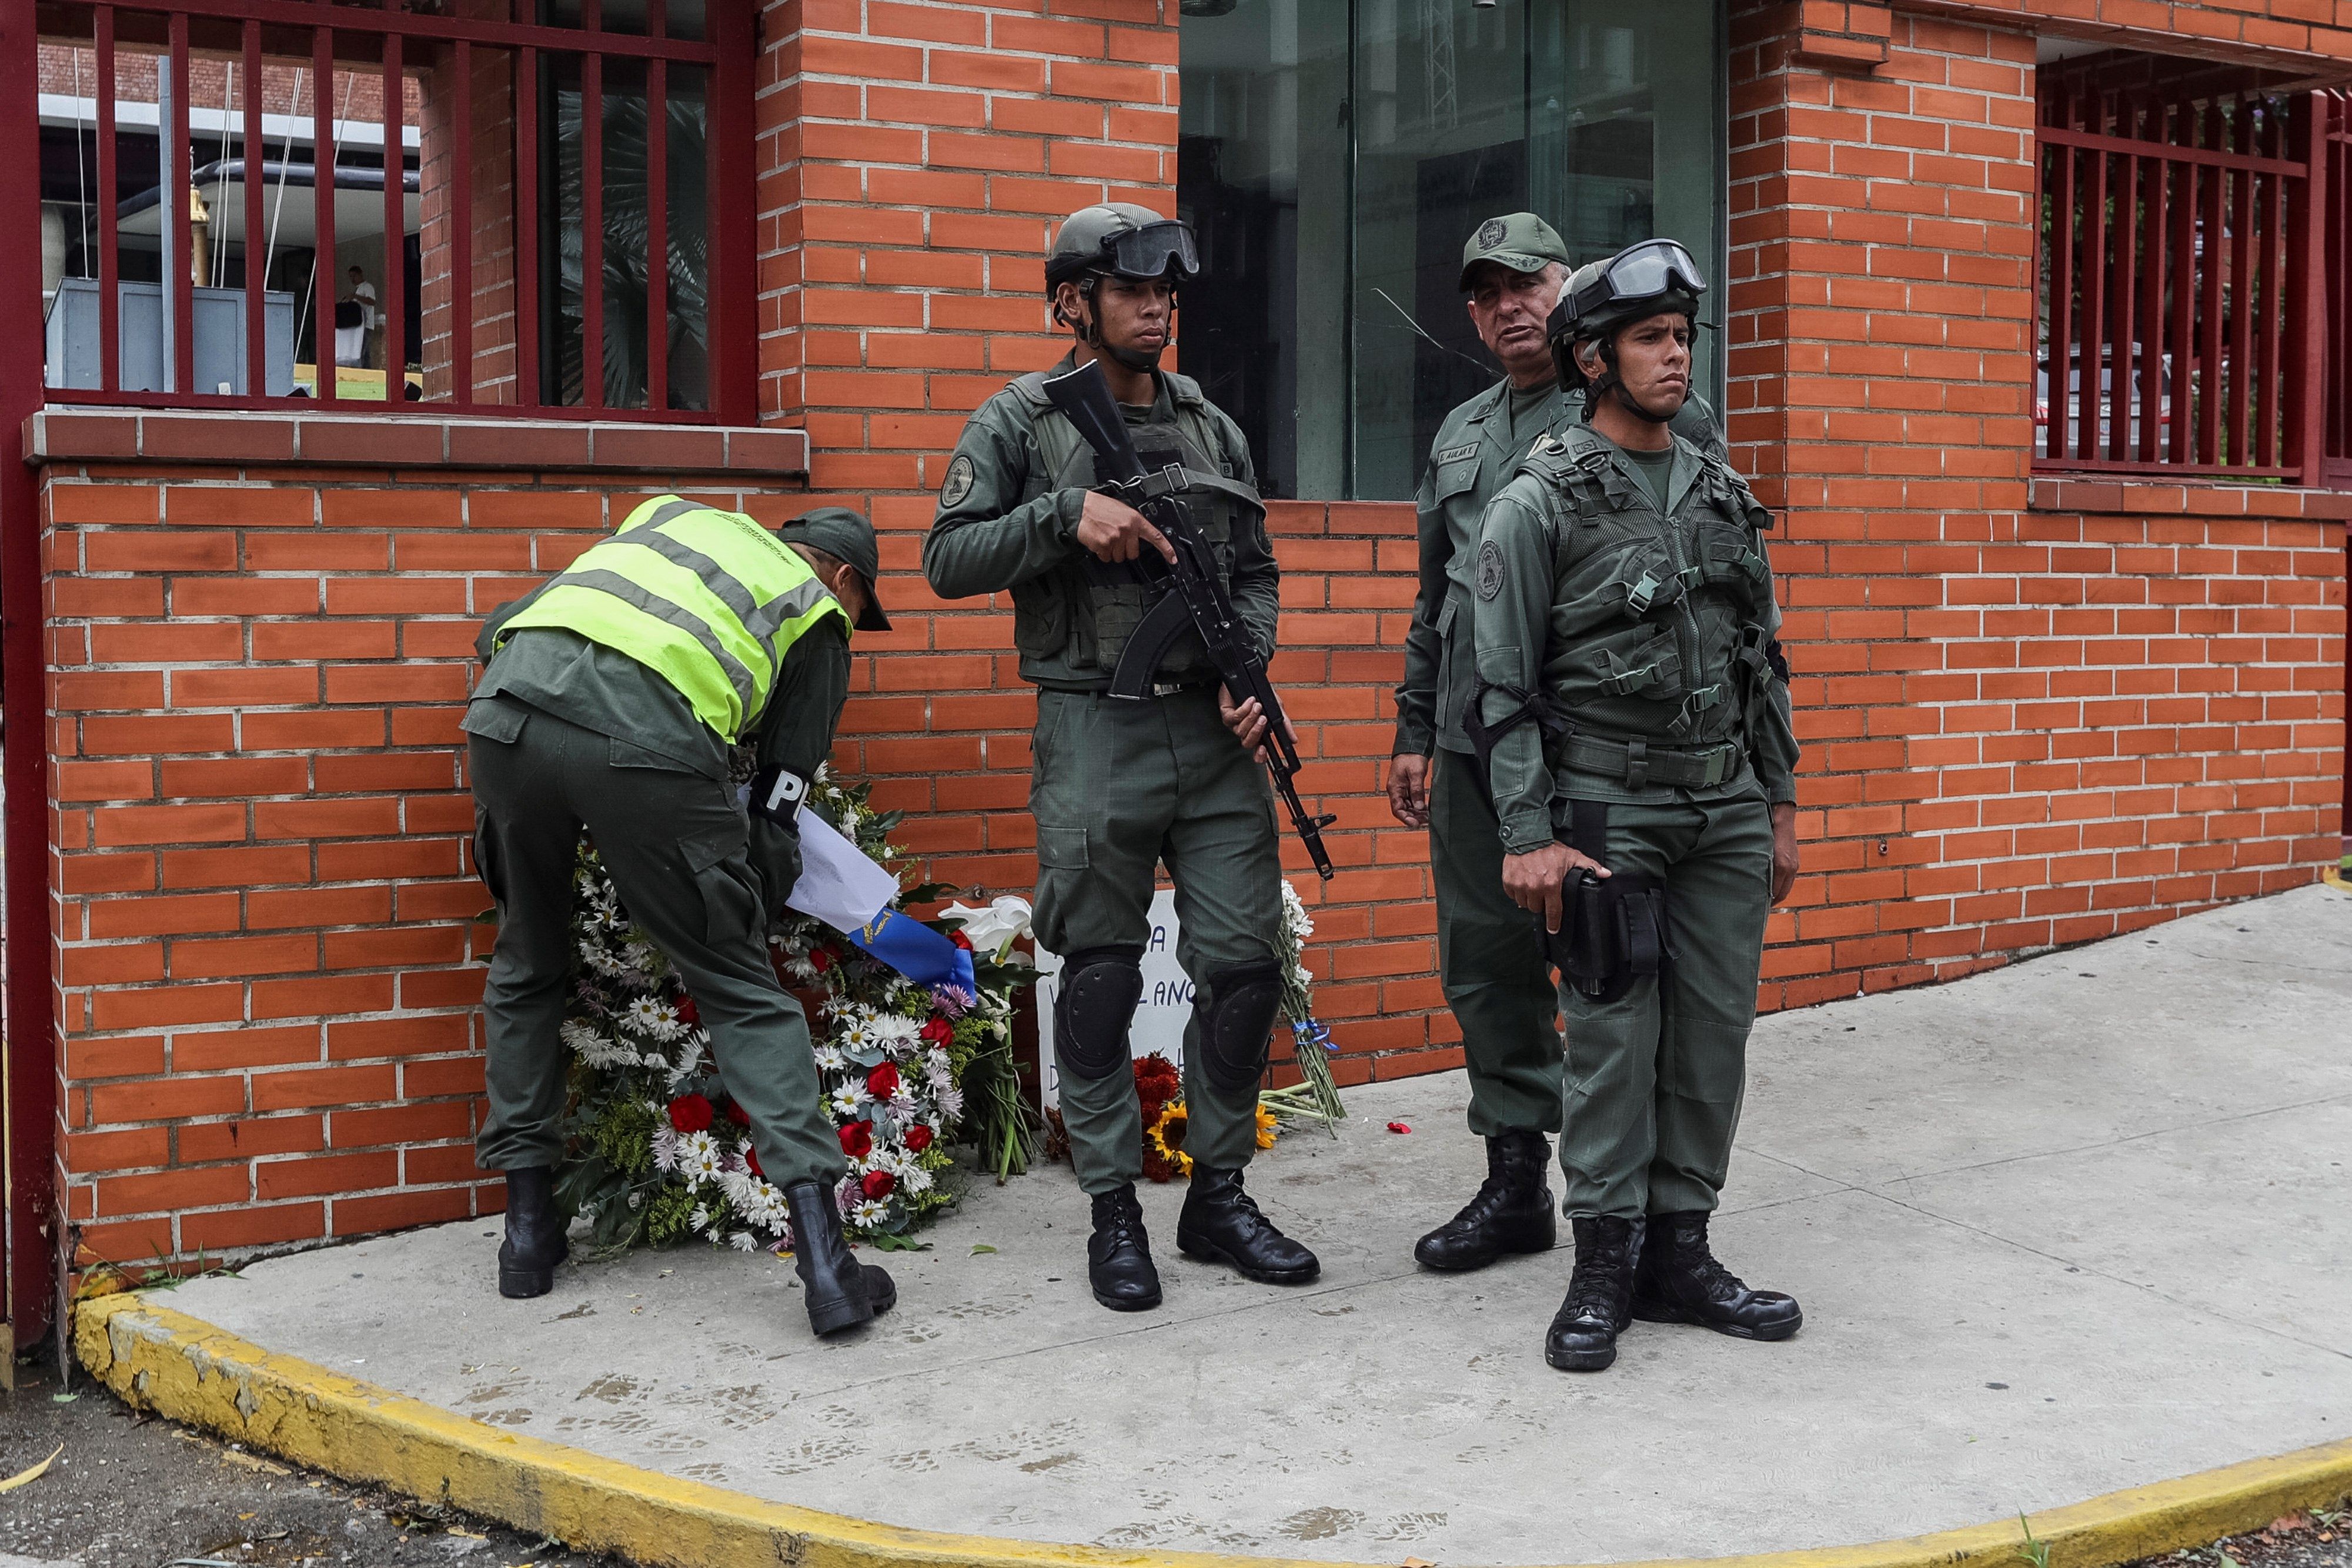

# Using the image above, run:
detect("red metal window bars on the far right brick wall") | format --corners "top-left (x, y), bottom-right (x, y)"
top-left (2034, 73), bottom-right (2347, 484)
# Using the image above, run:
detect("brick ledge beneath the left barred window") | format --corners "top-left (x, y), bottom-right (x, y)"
top-left (24, 402), bottom-right (809, 477)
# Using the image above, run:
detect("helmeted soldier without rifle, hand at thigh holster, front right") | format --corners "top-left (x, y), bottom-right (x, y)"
top-left (1470, 240), bottom-right (1802, 1370)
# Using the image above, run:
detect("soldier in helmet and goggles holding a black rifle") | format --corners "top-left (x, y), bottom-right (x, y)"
top-left (922, 202), bottom-right (1319, 1312)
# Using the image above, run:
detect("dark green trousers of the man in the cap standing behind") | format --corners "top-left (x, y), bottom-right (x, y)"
top-left (1430, 748), bottom-right (1559, 1138)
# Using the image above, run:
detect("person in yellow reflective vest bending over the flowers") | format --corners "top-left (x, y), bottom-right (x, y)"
top-left (463, 496), bottom-right (898, 1333)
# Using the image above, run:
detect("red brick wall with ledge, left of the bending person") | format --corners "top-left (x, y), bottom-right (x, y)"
top-left (29, 414), bottom-right (797, 1260)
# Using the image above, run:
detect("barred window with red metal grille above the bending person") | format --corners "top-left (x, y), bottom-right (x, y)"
top-left (38, 0), bottom-right (755, 423)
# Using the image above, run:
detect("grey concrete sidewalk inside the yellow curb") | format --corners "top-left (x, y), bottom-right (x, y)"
top-left (152, 888), bottom-right (2352, 1566)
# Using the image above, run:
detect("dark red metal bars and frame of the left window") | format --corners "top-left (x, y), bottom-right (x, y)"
top-left (40, 0), bottom-right (734, 423)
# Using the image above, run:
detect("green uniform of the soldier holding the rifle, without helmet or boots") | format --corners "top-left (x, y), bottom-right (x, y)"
top-left (922, 357), bottom-right (1282, 1194)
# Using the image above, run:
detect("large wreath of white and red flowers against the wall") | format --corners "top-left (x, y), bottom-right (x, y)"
top-left (557, 769), bottom-right (1035, 1251)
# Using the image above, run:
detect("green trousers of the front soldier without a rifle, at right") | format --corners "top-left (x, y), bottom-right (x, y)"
top-left (1559, 785), bottom-right (1771, 1218)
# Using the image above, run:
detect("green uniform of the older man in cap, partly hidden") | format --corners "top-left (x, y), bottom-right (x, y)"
top-left (1395, 381), bottom-right (1724, 1138)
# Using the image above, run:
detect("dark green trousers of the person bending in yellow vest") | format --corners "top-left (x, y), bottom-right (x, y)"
top-left (466, 698), bottom-right (849, 1187)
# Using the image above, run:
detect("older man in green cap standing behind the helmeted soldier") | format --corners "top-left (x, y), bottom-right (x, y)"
top-left (1388, 212), bottom-right (1722, 1269)
